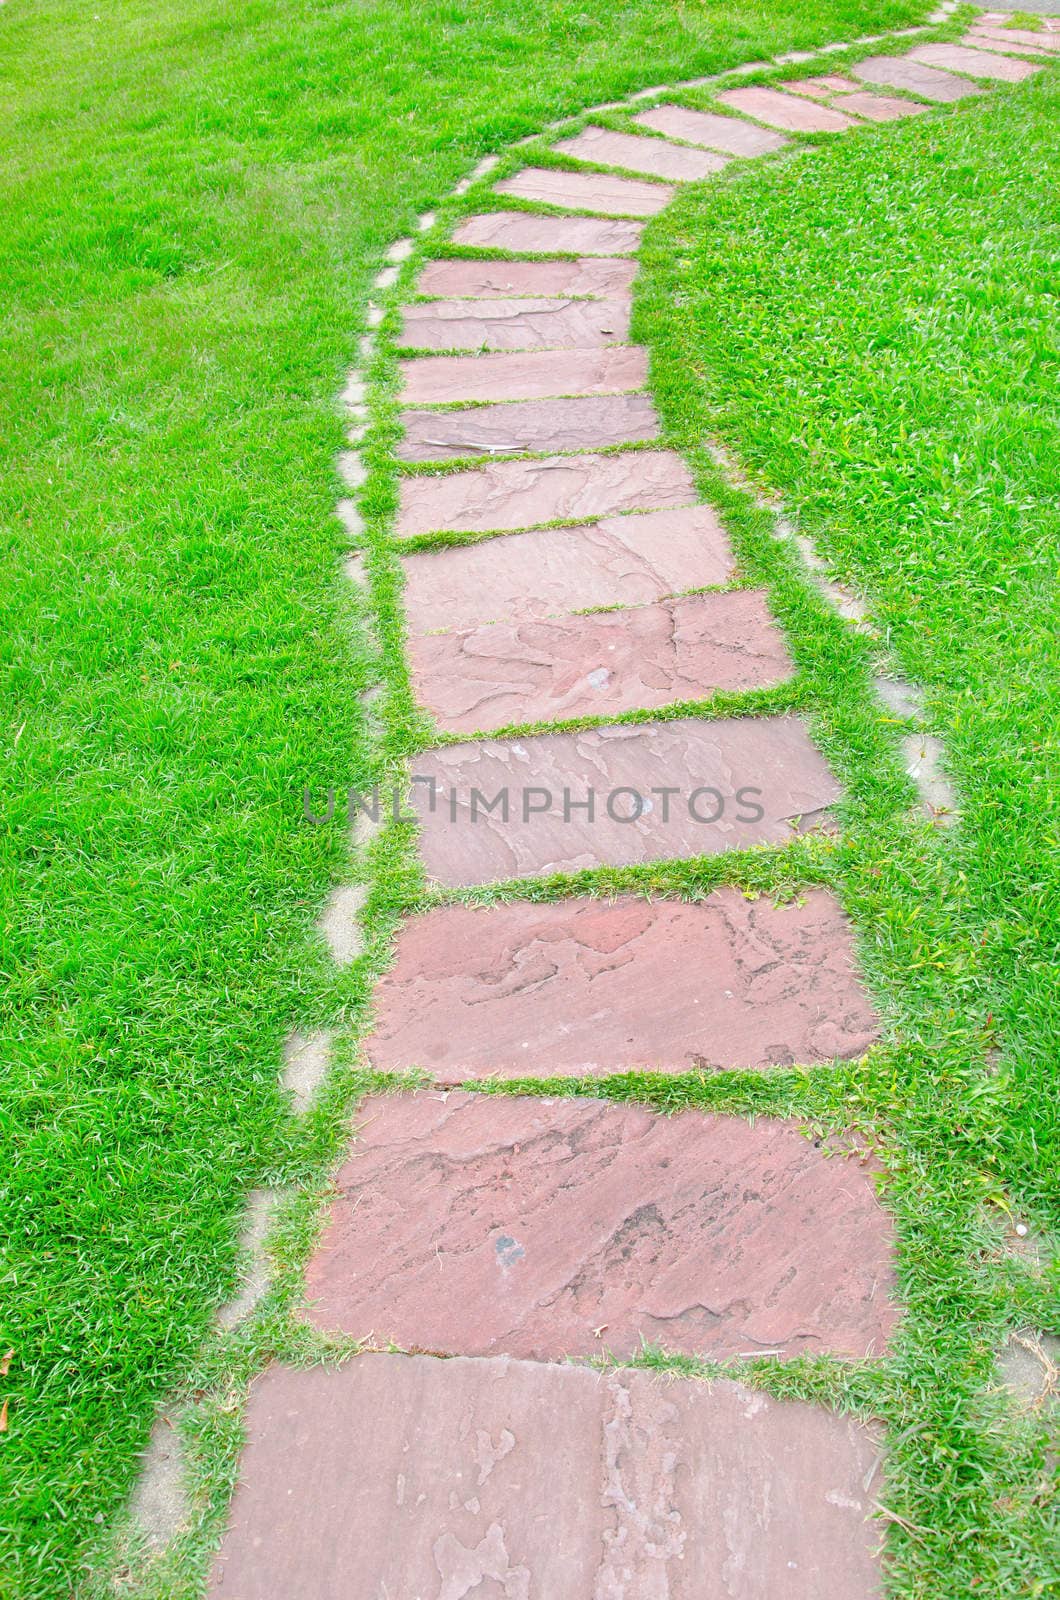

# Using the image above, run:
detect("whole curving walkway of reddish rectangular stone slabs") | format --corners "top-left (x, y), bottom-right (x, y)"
top-left (211, 13), bottom-right (1060, 1600)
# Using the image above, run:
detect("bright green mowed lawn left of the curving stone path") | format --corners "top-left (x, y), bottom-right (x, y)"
top-left (0, 0), bottom-right (941, 1597)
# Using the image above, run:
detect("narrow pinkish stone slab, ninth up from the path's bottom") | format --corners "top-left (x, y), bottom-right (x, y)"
top-left (397, 344), bottom-right (648, 405)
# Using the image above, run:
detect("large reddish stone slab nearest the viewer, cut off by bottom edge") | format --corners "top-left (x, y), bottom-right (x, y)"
top-left (210, 1354), bottom-right (882, 1600)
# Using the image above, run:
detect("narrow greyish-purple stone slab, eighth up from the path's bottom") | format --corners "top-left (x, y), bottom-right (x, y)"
top-left (394, 395), bottom-right (658, 461)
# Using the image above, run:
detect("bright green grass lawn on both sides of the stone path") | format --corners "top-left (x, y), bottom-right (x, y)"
top-left (0, 0), bottom-right (1057, 1600)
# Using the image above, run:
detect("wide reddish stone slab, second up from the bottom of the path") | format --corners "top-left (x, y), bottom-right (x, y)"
top-left (306, 1091), bottom-right (895, 1362)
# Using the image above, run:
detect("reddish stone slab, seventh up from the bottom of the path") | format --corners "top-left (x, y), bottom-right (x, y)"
top-left (394, 450), bottom-right (695, 539)
